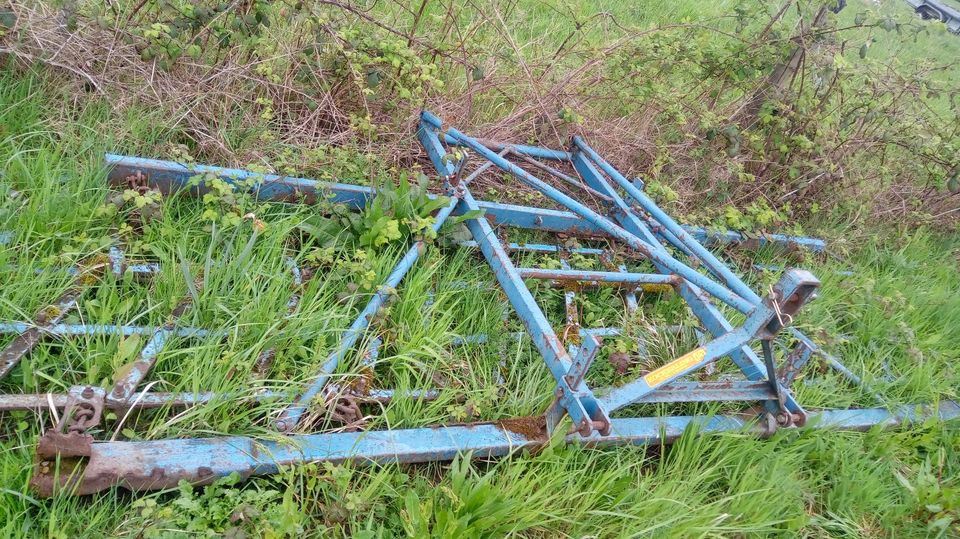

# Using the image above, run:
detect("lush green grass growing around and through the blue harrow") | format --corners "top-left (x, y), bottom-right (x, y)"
top-left (0, 3), bottom-right (960, 537)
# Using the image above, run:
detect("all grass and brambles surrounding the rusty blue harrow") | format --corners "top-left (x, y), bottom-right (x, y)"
top-left (0, 0), bottom-right (960, 537)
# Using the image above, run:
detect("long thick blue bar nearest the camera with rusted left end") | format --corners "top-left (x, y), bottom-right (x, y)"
top-left (32, 401), bottom-right (960, 496)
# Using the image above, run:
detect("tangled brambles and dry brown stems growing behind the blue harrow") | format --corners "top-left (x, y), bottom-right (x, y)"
top-left (0, 0), bottom-right (960, 229)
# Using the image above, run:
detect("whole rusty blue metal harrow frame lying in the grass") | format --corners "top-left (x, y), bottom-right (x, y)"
top-left (0, 112), bottom-right (960, 495)
